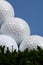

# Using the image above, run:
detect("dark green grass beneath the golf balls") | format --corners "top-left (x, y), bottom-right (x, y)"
top-left (0, 46), bottom-right (43, 65)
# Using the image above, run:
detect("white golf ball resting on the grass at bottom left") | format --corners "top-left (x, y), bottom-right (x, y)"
top-left (0, 35), bottom-right (18, 52)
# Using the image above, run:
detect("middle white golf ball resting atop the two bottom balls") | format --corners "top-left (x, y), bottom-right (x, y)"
top-left (1, 17), bottom-right (30, 45)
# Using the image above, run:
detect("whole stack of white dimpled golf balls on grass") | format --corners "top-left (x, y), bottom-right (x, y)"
top-left (0, 0), bottom-right (43, 52)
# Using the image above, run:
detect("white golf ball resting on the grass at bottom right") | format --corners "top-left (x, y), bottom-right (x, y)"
top-left (19, 35), bottom-right (42, 51)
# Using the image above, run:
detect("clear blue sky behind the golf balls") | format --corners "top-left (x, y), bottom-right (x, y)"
top-left (7, 0), bottom-right (43, 36)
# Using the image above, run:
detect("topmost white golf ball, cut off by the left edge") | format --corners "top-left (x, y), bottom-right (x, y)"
top-left (0, 0), bottom-right (14, 27)
